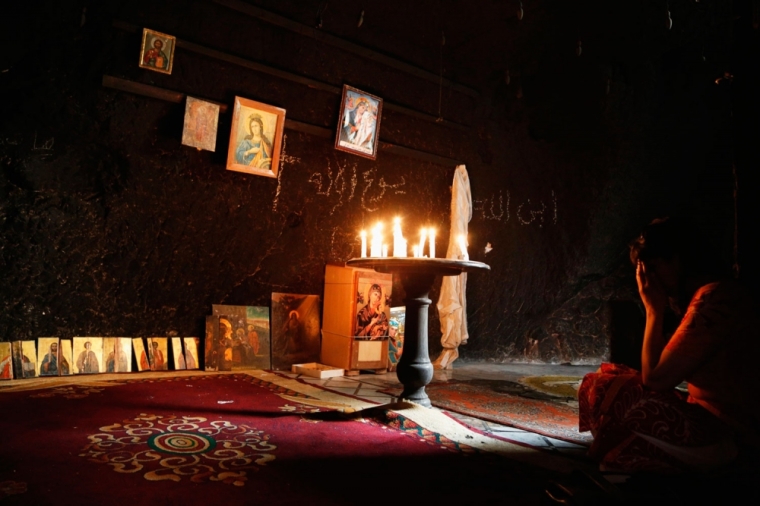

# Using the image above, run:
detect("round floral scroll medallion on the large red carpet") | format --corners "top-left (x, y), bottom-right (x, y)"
top-left (80, 413), bottom-right (277, 486)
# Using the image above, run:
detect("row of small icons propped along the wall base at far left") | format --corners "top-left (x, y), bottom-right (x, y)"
top-left (0, 337), bottom-right (199, 379)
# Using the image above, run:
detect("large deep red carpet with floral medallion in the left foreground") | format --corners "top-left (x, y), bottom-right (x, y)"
top-left (0, 374), bottom-right (568, 505)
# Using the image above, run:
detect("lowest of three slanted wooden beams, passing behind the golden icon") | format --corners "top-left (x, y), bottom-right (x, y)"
top-left (103, 75), bottom-right (462, 166)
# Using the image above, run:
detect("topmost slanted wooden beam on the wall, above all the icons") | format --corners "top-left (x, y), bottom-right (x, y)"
top-left (212, 0), bottom-right (479, 97)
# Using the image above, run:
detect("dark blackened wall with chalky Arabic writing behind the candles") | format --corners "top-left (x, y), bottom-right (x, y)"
top-left (0, 0), bottom-right (758, 363)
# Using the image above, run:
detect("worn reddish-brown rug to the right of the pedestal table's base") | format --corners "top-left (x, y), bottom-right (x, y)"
top-left (382, 380), bottom-right (592, 446)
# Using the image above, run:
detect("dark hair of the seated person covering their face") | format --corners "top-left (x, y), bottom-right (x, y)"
top-left (630, 218), bottom-right (725, 275)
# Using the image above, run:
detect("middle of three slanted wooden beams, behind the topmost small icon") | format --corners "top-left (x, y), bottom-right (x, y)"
top-left (113, 20), bottom-right (470, 131)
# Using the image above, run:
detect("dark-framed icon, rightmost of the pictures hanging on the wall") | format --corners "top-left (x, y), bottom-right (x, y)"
top-left (335, 85), bottom-right (383, 160)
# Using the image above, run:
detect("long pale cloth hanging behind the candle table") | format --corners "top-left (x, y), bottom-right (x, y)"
top-left (435, 165), bottom-right (472, 362)
